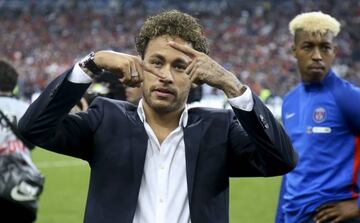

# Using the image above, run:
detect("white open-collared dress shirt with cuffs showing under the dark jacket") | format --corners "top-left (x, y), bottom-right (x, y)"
top-left (68, 64), bottom-right (254, 223)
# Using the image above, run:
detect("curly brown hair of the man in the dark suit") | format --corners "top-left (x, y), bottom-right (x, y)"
top-left (135, 10), bottom-right (209, 58)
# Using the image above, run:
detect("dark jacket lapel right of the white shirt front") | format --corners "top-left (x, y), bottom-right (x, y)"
top-left (184, 114), bottom-right (203, 205)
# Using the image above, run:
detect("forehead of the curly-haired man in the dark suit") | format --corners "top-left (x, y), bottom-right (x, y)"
top-left (145, 35), bottom-right (192, 60)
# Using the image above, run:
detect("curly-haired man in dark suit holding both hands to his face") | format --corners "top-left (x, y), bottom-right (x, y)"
top-left (19, 11), bottom-right (297, 223)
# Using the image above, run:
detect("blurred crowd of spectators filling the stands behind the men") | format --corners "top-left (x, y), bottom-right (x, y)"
top-left (0, 0), bottom-right (360, 98)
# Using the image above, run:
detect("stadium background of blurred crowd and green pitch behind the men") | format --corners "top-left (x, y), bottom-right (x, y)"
top-left (0, 0), bottom-right (360, 223)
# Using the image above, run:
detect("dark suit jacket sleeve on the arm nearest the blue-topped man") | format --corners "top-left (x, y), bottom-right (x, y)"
top-left (228, 94), bottom-right (298, 177)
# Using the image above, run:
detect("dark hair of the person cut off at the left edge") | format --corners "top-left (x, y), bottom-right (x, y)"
top-left (0, 60), bottom-right (19, 92)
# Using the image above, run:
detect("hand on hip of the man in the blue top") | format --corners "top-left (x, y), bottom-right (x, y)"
top-left (314, 199), bottom-right (360, 223)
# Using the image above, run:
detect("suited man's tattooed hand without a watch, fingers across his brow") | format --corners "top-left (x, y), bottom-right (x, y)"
top-left (169, 41), bottom-right (244, 98)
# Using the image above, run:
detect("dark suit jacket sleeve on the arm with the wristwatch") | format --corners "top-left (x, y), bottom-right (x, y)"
top-left (18, 70), bottom-right (101, 160)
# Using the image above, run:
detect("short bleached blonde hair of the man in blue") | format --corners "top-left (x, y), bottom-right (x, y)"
top-left (289, 11), bottom-right (340, 37)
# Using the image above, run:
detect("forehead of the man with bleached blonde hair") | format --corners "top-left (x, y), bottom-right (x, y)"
top-left (295, 31), bottom-right (334, 44)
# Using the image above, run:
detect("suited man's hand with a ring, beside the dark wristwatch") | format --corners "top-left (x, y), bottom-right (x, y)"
top-left (94, 50), bottom-right (163, 87)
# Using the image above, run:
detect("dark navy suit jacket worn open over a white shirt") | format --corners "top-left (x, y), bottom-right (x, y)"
top-left (19, 71), bottom-right (297, 223)
